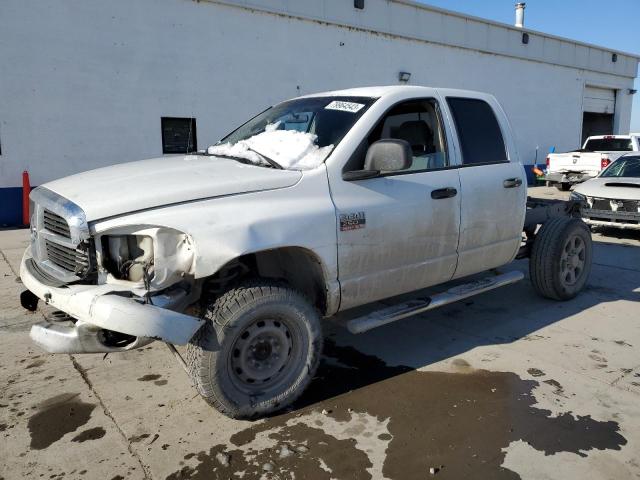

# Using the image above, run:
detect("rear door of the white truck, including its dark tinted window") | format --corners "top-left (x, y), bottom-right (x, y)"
top-left (447, 97), bottom-right (527, 278)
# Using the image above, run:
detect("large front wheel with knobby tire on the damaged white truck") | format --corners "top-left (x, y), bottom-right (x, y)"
top-left (186, 279), bottom-right (323, 419)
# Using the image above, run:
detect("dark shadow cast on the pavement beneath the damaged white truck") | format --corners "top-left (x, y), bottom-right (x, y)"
top-left (294, 260), bottom-right (640, 409)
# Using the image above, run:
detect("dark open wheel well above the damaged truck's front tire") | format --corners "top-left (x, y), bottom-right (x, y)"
top-left (204, 247), bottom-right (327, 314)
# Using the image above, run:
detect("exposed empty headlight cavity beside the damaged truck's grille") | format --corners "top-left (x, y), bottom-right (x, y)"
top-left (102, 235), bottom-right (153, 282)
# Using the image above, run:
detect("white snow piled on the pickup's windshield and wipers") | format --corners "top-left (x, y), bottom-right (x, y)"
top-left (207, 123), bottom-right (333, 170)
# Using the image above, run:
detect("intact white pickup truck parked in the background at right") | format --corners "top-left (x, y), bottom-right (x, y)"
top-left (545, 134), bottom-right (640, 191)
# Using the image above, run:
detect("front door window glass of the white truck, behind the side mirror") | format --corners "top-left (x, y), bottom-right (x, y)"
top-left (346, 99), bottom-right (449, 173)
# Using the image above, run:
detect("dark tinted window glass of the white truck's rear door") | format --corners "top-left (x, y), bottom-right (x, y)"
top-left (447, 98), bottom-right (508, 165)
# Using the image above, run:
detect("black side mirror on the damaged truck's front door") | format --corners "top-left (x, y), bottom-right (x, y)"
top-left (342, 139), bottom-right (413, 182)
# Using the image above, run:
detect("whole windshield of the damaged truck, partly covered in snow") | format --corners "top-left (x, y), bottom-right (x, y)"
top-left (207, 97), bottom-right (376, 170)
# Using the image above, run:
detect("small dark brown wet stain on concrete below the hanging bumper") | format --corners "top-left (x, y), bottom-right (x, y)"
top-left (27, 393), bottom-right (96, 450)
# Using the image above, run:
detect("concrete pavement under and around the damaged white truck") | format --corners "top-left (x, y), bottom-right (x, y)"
top-left (0, 188), bottom-right (640, 480)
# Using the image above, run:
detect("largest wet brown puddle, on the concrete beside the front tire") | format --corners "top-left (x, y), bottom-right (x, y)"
top-left (167, 341), bottom-right (627, 480)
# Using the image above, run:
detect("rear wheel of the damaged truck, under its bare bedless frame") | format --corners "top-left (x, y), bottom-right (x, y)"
top-left (529, 217), bottom-right (593, 300)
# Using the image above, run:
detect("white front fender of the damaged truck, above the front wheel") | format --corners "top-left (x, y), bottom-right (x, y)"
top-left (94, 170), bottom-right (339, 316)
